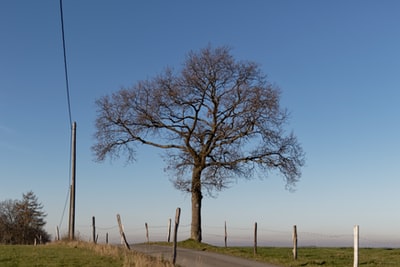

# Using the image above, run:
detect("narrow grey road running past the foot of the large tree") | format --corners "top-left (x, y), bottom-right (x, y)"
top-left (131, 244), bottom-right (279, 267)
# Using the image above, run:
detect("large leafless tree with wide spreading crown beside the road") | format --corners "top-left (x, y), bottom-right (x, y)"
top-left (92, 46), bottom-right (304, 242)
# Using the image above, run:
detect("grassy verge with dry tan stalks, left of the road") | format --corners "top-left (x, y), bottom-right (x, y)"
top-left (0, 241), bottom-right (173, 267)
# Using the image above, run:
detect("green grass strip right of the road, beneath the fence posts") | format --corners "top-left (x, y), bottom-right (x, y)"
top-left (171, 240), bottom-right (400, 267)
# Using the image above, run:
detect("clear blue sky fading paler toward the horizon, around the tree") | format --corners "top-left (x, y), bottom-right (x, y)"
top-left (0, 0), bottom-right (400, 246)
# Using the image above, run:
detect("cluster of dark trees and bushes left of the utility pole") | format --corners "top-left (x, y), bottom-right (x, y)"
top-left (0, 191), bottom-right (50, 244)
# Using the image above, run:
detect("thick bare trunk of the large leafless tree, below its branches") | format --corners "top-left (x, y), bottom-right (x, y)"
top-left (190, 167), bottom-right (203, 242)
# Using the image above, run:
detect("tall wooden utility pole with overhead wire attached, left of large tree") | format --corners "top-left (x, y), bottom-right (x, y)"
top-left (69, 122), bottom-right (76, 240)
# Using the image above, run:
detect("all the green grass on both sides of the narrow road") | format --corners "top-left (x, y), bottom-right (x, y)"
top-left (0, 240), bottom-right (400, 267)
